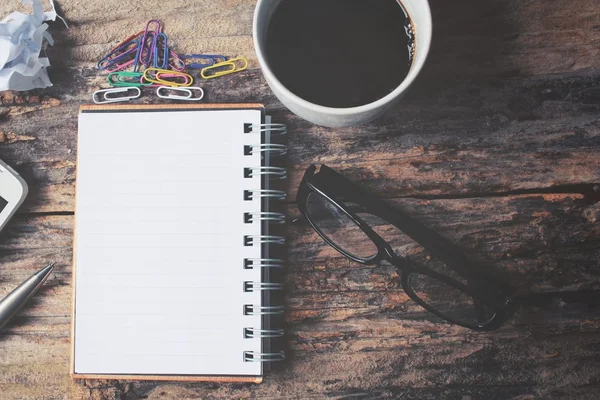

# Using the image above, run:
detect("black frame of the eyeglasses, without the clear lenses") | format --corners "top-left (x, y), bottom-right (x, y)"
top-left (296, 165), bottom-right (519, 331)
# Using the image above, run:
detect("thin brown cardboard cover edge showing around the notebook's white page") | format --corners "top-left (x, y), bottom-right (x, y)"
top-left (70, 103), bottom-right (264, 383)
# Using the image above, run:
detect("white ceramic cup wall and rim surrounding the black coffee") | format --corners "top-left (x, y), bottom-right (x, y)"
top-left (253, 0), bottom-right (431, 127)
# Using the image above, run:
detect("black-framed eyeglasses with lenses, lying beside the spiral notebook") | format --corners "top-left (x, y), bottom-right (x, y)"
top-left (297, 165), bottom-right (518, 331)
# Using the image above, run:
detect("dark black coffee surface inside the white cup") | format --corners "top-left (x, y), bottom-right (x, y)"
top-left (266, 0), bottom-right (414, 108)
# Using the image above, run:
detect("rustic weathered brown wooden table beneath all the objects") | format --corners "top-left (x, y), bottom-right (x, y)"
top-left (0, 0), bottom-right (600, 400)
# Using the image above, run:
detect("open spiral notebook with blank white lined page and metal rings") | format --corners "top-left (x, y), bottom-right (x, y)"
top-left (71, 104), bottom-right (287, 383)
